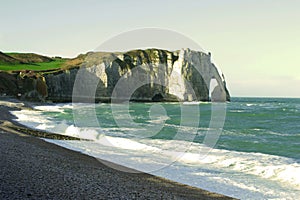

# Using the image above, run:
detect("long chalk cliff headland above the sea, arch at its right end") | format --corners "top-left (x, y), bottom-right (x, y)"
top-left (0, 49), bottom-right (230, 102)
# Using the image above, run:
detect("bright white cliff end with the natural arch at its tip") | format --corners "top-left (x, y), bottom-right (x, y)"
top-left (169, 49), bottom-right (226, 101)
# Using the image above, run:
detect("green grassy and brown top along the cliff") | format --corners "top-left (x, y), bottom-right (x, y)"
top-left (0, 48), bottom-right (205, 71)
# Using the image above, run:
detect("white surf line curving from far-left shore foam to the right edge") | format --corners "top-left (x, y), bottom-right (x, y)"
top-left (12, 104), bottom-right (300, 186)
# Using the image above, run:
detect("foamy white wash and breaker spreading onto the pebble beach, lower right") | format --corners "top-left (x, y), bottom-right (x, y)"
top-left (47, 136), bottom-right (300, 199)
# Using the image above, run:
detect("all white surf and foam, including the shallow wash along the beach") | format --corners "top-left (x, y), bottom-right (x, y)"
top-left (12, 104), bottom-right (300, 198)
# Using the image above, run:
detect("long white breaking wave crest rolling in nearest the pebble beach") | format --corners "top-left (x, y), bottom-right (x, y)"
top-left (40, 122), bottom-right (300, 187)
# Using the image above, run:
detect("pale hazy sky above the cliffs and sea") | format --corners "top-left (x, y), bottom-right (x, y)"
top-left (0, 0), bottom-right (300, 97)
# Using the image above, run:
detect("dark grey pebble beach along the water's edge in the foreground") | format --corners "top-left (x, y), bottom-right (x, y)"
top-left (0, 98), bottom-right (232, 199)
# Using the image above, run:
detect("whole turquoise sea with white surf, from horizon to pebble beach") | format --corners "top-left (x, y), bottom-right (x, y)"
top-left (12, 97), bottom-right (300, 199)
